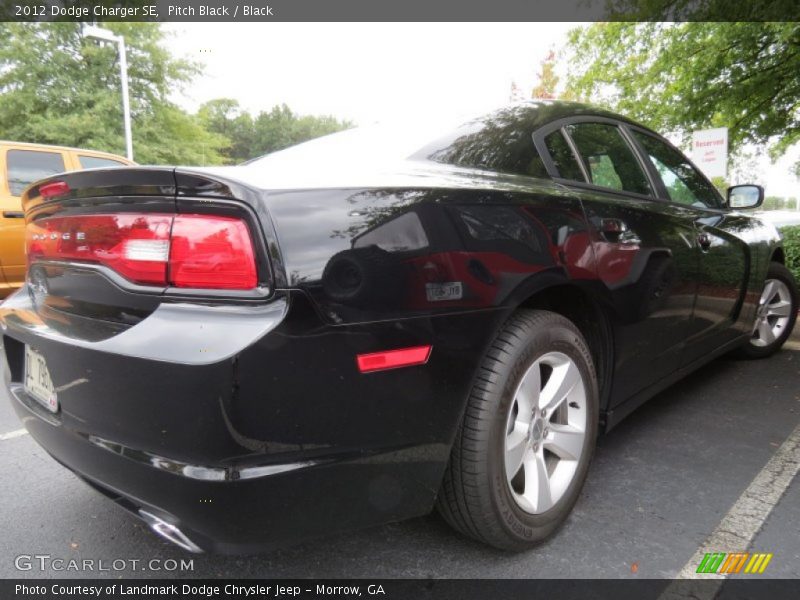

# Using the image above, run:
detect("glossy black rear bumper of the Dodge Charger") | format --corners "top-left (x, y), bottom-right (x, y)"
top-left (0, 289), bottom-right (502, 553)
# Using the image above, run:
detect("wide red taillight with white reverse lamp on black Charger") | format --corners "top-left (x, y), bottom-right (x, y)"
top-left (26, 214), bottom-right (258, 290)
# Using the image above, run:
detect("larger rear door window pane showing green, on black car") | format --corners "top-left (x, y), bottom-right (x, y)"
top-left (565, 123), bottom-right (652, 195)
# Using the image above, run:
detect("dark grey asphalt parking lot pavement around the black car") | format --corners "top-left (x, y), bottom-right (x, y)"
top-left (0, 339), bottom-right (800, 578)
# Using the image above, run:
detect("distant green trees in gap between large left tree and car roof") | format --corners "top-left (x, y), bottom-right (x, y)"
top-left (198, 98), bottom-right (352, 164)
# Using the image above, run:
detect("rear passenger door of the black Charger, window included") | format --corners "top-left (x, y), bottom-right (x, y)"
top-left (535, 117), bottom-right (697, 408)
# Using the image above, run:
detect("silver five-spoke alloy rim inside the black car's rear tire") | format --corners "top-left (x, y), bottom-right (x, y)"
top-left (504, 352), bottom-right (587, 514)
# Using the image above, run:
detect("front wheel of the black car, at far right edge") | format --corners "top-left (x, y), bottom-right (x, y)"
top-left (740, 263), bottom-right (798, 358)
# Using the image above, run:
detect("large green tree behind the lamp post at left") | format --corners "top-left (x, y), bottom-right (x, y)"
top-left (0, 22), bottom-right (227, 164)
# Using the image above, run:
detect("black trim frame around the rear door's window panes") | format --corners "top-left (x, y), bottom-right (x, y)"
top-left (533, 115), bottom-right (664, 202)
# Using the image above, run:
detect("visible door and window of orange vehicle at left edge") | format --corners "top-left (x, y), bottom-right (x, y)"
top-left (0, 145), bottom-right (66, 287)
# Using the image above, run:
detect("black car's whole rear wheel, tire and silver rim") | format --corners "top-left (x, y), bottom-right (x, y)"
top-left (438, 310), bottom-right (598, 550)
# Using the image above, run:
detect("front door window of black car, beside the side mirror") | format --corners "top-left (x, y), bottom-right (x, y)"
top-left (633, 131), bottom-right (720, 208)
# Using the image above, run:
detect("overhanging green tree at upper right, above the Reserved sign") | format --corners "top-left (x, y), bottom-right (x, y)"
top-left (566, 23), bottom-right (800, 175)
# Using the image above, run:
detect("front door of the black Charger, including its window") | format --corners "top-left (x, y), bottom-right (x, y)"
top-left (630, 127), bottom-right (750, 364)
